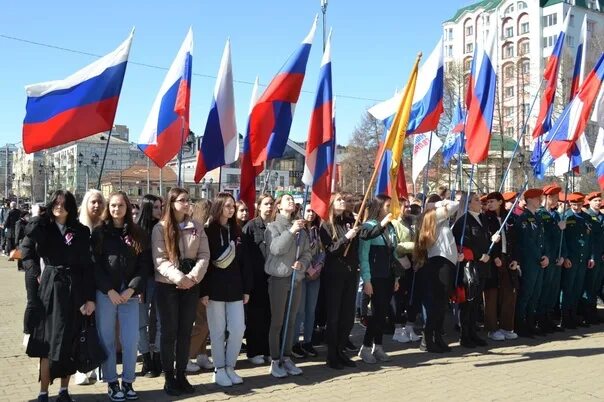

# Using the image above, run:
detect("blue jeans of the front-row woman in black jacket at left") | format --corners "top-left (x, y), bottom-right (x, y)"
top-left (95, 290), bottom-right (139, 383)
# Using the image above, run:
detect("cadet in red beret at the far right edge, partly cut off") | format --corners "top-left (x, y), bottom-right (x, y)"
top-left (581, 192), bottom-right (604, 324)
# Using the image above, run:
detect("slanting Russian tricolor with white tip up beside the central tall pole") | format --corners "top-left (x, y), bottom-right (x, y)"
top-left (249, 17), bottom-right (318, 166)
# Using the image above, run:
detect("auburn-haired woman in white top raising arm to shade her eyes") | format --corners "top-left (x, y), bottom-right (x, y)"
top-left (413, 195), bottom-right (463, 353)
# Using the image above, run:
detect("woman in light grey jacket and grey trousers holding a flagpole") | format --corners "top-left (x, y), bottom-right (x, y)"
top-left (264, 194), bottom-right (311, 378)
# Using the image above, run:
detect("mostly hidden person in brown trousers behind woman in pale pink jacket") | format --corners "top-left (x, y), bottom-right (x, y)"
top-left (187, 199), bottom-right (214, 373)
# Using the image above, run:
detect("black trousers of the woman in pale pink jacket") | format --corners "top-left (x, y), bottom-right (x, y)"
top-left (156, 282), bottom-right (199, 372)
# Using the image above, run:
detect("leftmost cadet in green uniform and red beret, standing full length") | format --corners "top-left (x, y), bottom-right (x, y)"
top-left (515, 188), bottom-right (549, 337)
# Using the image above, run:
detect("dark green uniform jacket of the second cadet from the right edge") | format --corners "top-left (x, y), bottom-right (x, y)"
top-left (564, 210), bottom-right (593, 265)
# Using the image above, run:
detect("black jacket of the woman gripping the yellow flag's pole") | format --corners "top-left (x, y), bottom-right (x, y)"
top-left (319, 215), bottom-right (359, 276)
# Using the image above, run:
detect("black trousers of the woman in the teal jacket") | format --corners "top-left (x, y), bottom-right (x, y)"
top-left (363, 278), bottom-right (394, 347)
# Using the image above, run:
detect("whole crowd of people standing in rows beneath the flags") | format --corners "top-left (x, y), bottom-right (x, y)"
top-left (0, 185), bottom-right (604, 402)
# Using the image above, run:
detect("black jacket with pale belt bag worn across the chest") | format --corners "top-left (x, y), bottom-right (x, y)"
top-left (200, 222), bottom-right (252, 302)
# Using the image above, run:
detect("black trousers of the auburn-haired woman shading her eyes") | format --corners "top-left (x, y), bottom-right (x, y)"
top-left (420, 256), bottom-right (455, 333)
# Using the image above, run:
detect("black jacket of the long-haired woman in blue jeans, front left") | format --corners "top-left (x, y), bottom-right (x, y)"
top-left (91, 222), bottom-right (151, 294)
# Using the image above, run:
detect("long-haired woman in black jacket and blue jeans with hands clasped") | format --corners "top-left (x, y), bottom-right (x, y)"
top-left (92, 191), bottom-right (151, 402)
